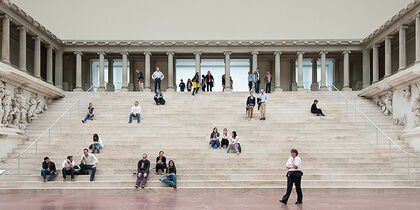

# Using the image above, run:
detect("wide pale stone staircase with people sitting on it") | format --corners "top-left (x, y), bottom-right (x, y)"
top-left (0, 92), bottom-right (420, 193)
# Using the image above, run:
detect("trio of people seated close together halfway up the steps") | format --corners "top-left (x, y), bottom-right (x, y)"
top-left (209, 128), bottom-right (241, 155)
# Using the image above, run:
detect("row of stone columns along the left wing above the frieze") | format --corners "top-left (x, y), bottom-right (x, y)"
top-left (1, 15), bottom-right (63, 88)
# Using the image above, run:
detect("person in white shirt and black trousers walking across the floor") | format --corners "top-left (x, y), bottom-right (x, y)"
top-left (280, 149), bottom-right (303, 204)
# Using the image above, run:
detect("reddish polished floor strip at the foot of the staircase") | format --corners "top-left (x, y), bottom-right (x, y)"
top-left (0, 193), bottom-right (420, 210)
